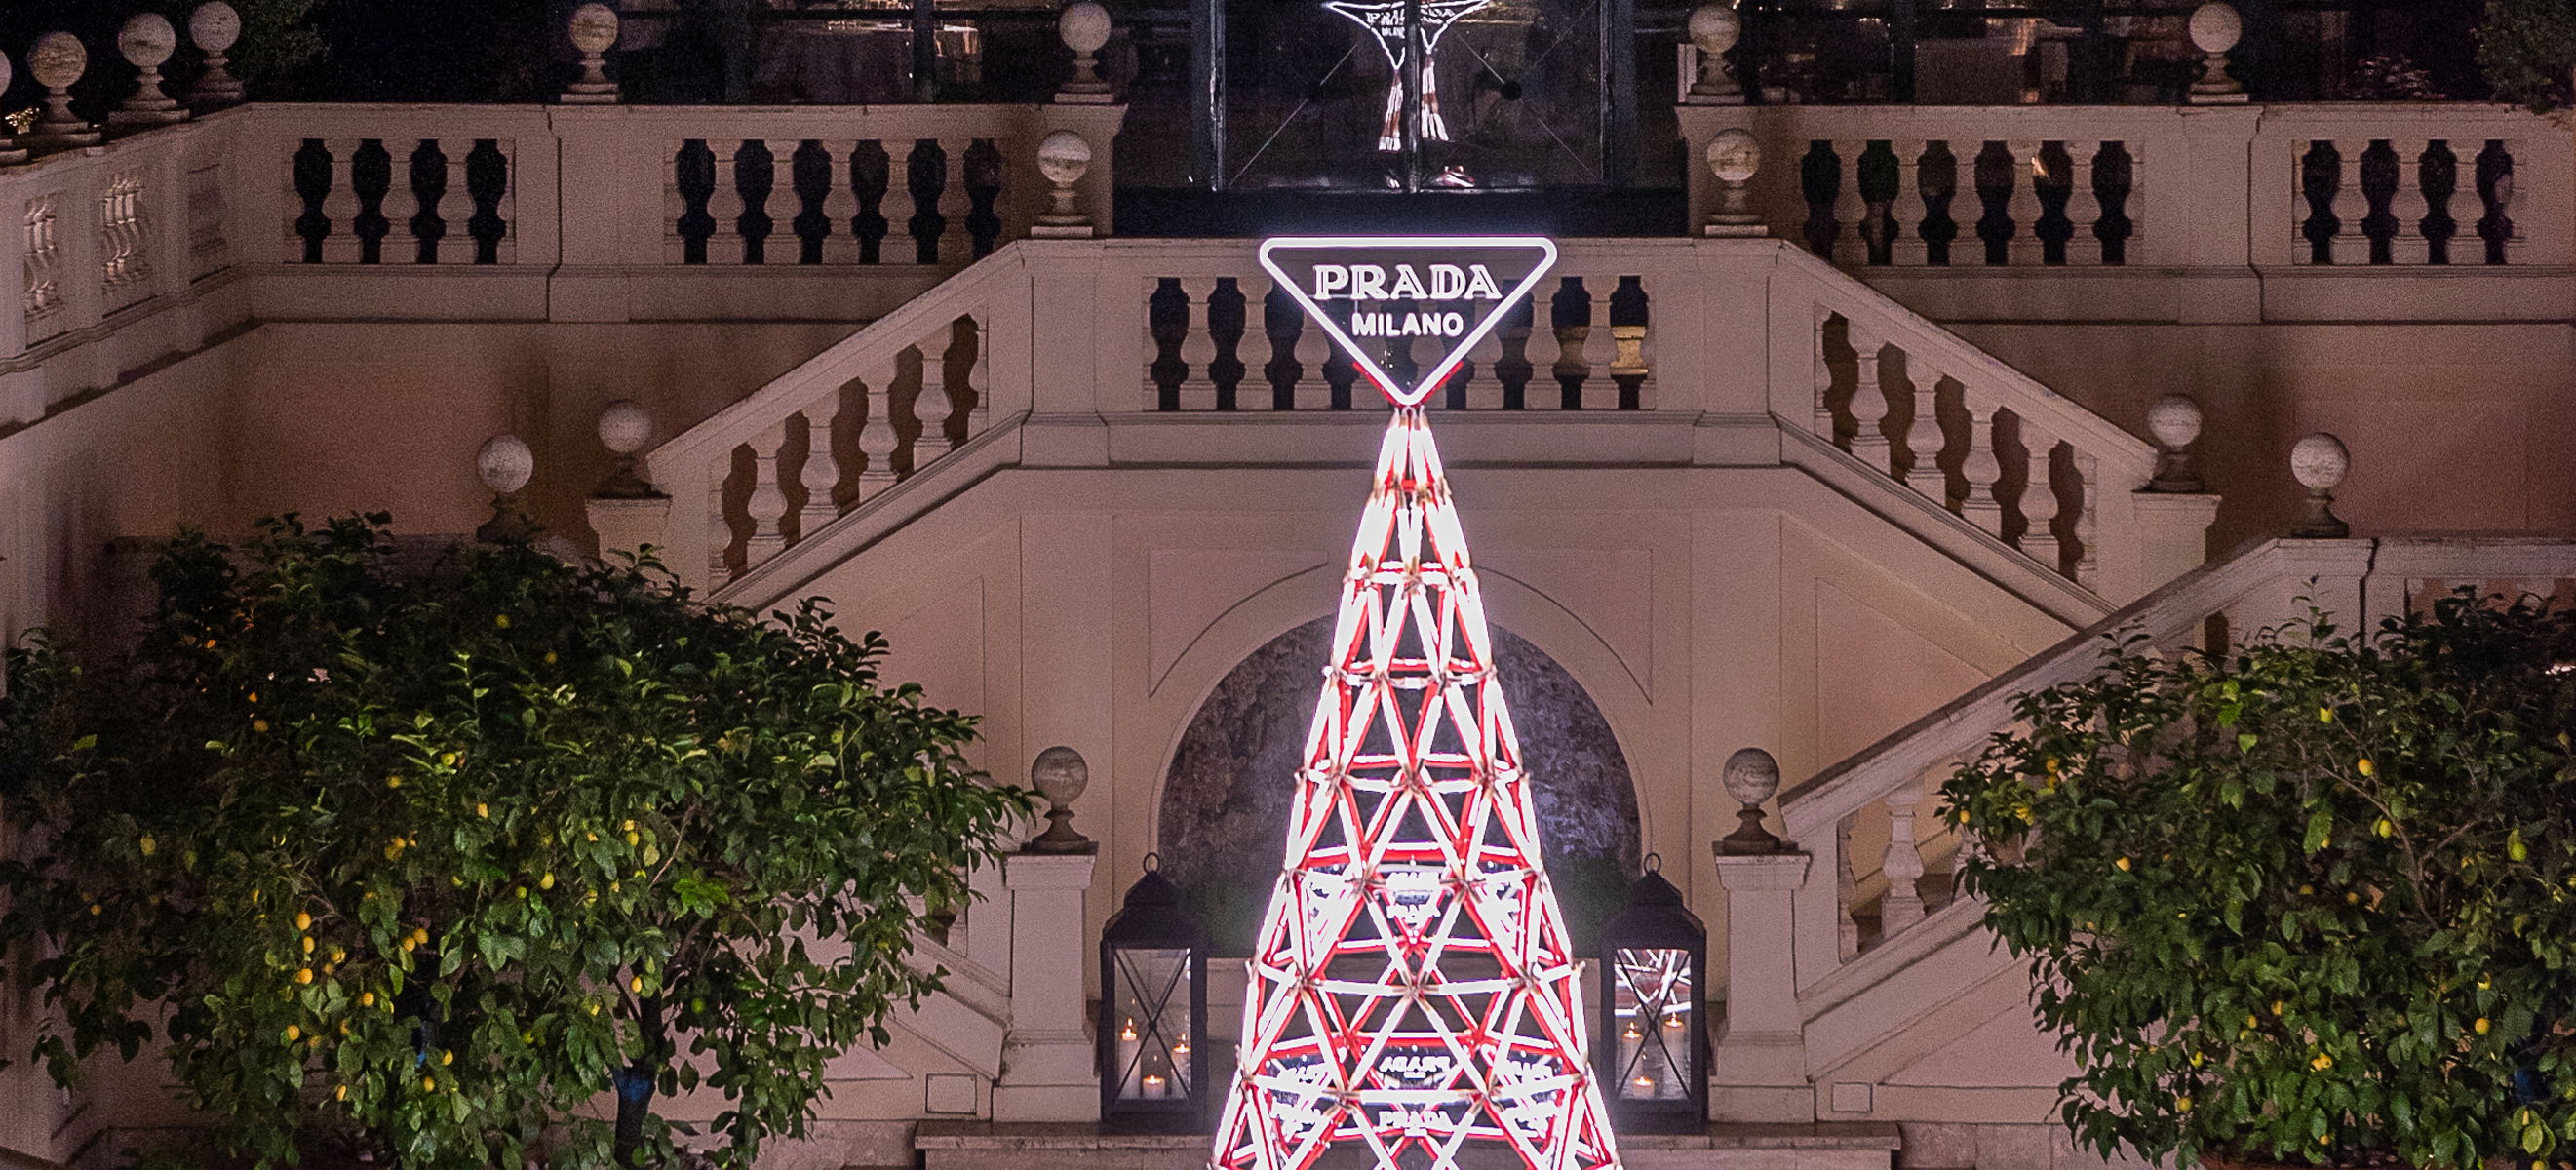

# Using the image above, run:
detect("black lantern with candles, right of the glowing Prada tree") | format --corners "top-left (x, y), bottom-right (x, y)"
top-left (1592, 853), bottom-right (1708, 1134)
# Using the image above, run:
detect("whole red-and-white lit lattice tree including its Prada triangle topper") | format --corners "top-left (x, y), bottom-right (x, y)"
top-left (1211, 237), bottom-right (1618, 1170)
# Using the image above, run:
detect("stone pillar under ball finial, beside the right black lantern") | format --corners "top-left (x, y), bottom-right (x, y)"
top-left (1708, 850), bottom-right (1816, 1121)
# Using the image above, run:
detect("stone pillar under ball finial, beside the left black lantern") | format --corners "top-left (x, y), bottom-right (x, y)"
top-left (992, 853), bottom-right (1100, 1121)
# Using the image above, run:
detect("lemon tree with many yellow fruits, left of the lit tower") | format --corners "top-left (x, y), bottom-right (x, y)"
top-left (0, 516), bottom-right (1026, 1167)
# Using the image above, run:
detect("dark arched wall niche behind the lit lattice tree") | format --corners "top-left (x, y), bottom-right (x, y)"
top-left (1154, 618), bottom-right (1638, 956)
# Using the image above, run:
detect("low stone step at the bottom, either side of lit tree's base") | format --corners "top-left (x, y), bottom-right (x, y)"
top-left (912, 1121), bottom-right (1898, 1170)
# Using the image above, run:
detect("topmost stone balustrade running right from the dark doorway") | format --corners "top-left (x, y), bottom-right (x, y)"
top-left (1680, 103), bottom-right (2576, 268)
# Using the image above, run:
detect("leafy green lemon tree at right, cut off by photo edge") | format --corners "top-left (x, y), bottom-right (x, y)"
top-left (1942, 596), bottom-right (2576, 1170)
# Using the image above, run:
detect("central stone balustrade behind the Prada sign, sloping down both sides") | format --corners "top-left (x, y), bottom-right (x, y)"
top-left (628, 240), bottom-right (2210, 613)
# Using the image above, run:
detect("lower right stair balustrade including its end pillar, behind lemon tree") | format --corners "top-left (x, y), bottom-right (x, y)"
top-left (1716, 518), bottom-right (2576, 1121)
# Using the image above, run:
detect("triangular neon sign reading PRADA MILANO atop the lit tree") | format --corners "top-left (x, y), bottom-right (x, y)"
top-left (1260, 235), bottom-right (1556, 408)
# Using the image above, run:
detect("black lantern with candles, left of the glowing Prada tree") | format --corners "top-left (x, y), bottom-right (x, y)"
top-left (1100, 853), bottom-right (1208, 1134)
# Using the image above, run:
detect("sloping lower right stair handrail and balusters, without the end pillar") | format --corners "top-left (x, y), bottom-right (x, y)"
top-left (1780, 538), bottom-right (2576, 993)
